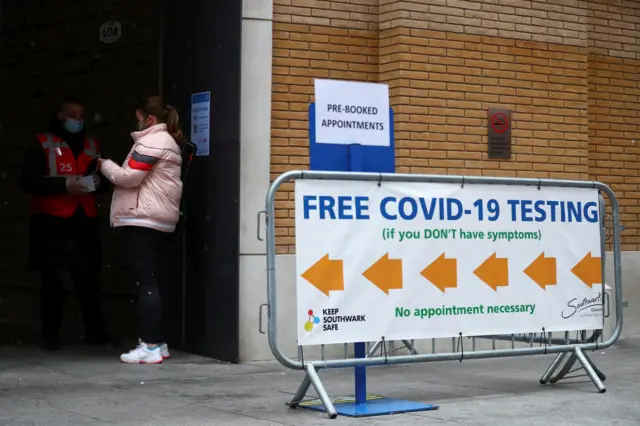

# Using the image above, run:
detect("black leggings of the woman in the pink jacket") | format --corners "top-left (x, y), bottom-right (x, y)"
top-left (122, 226), bottom-right (171, 343)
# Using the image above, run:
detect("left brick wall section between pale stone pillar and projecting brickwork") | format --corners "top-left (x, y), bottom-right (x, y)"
top-left (271, 0), bottom-right (378, 253)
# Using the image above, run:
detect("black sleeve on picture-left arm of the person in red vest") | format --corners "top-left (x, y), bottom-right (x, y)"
top-left (20, 141), bottom-right (67, 195)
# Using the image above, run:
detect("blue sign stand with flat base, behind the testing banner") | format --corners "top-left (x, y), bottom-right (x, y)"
top-left (300, 103), bottom-right (439, 417)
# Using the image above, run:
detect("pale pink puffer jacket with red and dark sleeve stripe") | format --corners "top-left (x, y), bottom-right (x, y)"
top-left (100, 124), bottom-right (182, 232)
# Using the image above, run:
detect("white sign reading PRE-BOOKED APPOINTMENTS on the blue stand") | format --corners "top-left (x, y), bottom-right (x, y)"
top-left (315, 80), bottom-right (391, 146)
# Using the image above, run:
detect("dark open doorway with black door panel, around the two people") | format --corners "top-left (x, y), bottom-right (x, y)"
top-left (0, 0), bottom-right (241, 362)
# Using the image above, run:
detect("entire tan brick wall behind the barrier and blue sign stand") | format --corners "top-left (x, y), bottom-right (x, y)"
top-left (271, 0), bottom-right (640, 253)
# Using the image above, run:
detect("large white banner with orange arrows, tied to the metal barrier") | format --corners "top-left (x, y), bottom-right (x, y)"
top-left (295, 180), bottom-right (603, 345)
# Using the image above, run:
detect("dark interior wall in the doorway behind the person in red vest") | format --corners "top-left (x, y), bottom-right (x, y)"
top-left (0, 0), bottom-right (161, 341)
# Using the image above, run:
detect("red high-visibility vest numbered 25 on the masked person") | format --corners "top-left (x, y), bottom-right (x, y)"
top-left (32, 134), bottom-right (100, 218)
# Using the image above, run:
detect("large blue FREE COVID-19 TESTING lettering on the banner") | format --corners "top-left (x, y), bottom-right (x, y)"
top-left (303, 195), bottom-right (599, 223)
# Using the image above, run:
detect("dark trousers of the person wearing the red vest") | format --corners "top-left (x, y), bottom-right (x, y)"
top-left (40, 266), bottom-right (107, 341)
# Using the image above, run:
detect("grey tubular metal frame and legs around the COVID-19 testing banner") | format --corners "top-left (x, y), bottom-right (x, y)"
top-left (266, 171), bottom-right (624, 418)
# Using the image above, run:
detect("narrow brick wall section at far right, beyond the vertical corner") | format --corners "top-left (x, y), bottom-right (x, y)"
top-left (588, 0), bottom-right (640, 250)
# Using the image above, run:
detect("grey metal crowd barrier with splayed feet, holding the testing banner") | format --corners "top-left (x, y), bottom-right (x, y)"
top-left (266, 171), bottom-right (623, 418)
